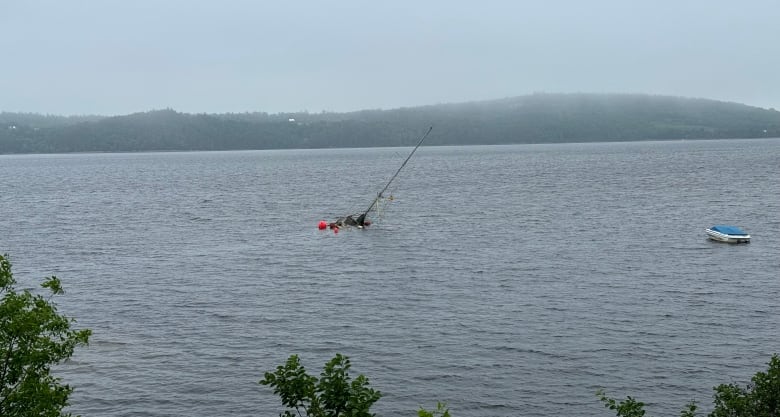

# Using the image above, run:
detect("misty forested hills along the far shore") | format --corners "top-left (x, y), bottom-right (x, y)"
top-left (0, 94), bottom-right (780, 153)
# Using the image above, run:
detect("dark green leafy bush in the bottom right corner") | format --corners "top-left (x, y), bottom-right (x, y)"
top-left (710, 354), bottom-right (780, 417)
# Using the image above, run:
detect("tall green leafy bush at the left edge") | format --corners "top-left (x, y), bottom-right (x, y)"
top-left (0, 255), bottom-right (91, 417)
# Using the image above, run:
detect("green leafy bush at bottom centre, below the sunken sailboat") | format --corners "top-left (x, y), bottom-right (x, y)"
top-left (260, 354), bottom-right (382, 417)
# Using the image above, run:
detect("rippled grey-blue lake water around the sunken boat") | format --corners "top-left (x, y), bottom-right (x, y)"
top-left (0, 140), bottom-right (780, 417)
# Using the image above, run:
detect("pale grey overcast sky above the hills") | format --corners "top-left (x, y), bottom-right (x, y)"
top-left (0, 0), bottom-right (780, 115)
